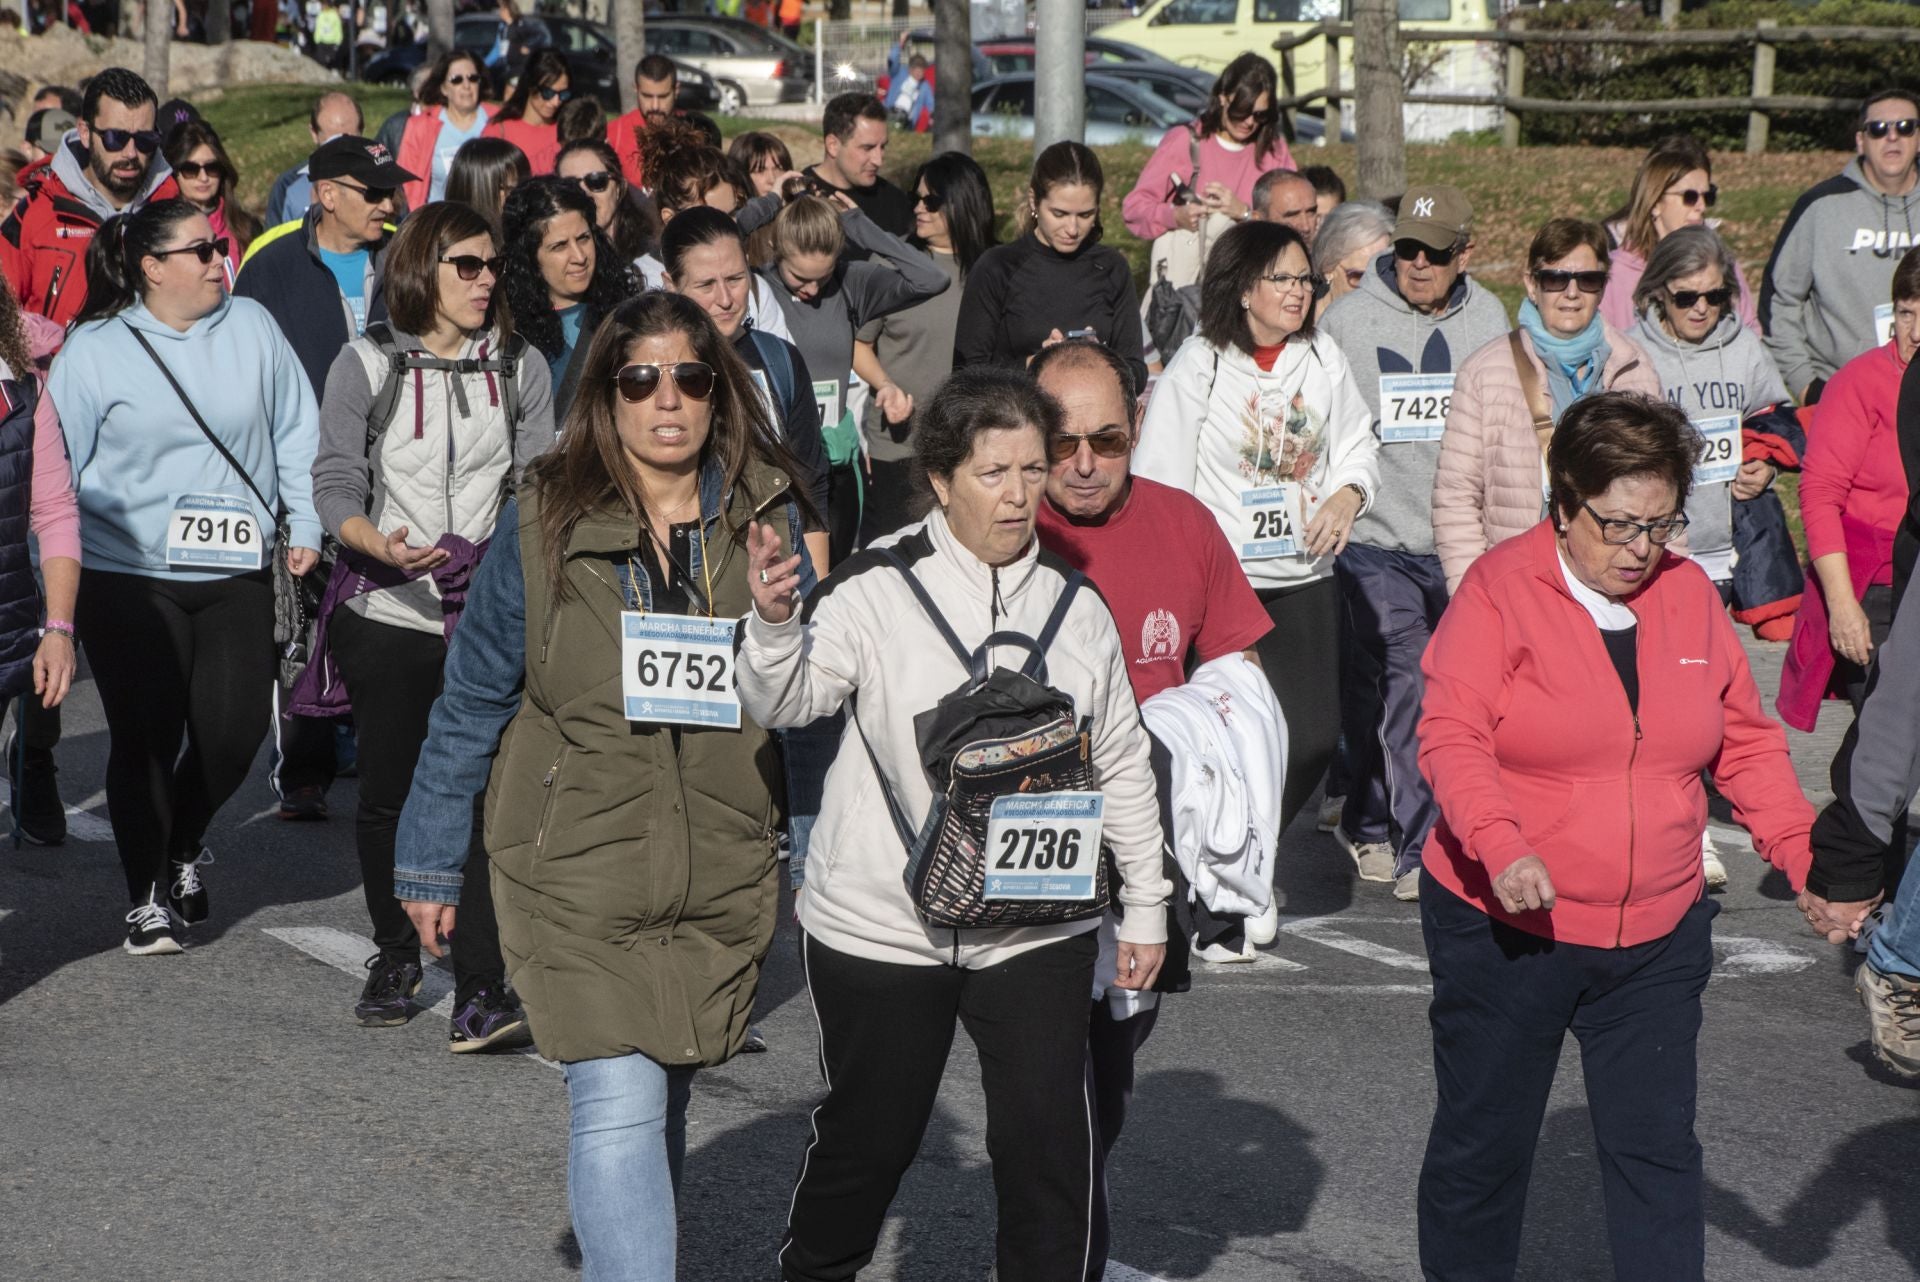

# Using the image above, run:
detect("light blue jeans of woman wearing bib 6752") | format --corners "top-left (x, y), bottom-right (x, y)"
top-left (566, 1054), bottom-right (693, 1282)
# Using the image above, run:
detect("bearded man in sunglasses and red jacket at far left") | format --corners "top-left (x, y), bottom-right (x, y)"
top-left (0, 67), bottom-right (180, 324)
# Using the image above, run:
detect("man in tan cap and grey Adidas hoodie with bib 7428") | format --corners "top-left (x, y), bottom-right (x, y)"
top-left (1321, 184), bottom-right (1507, 900)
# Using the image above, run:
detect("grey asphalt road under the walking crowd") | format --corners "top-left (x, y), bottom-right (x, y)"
top-left (0, 647), bottom-right (1920, 1282)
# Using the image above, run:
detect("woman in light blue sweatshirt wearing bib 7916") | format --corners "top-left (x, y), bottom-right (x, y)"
top-left (48, 200), bottom-right (321, 954)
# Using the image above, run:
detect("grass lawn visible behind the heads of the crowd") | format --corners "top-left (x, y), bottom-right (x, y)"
top-left (204, 84), bottom-right (1812, 541)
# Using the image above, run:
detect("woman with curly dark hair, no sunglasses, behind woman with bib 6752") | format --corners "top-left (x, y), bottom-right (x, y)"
top-left (499, 178), bottom-right (634, 418)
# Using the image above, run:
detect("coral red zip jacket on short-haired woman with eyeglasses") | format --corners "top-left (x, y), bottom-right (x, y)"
top-left (1421, 522), bottom-right (1814, 948)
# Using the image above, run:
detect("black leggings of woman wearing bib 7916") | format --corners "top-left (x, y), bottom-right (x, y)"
top-left (73, 570), bottom-right (275, 904)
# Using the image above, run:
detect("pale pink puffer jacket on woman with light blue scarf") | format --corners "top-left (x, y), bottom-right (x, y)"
top-left (1432, 324), bottom-right (1661, 591)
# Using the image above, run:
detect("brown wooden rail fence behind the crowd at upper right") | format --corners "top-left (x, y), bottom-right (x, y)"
top-left (1273, 17), bottom-right (1896, 155)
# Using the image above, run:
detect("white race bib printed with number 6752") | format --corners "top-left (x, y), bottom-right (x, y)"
top-left (620, 610), bottom-right (739, 729)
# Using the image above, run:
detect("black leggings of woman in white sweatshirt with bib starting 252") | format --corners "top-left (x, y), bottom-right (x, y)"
top-left (1254, 576), bottom-right (1340, 833)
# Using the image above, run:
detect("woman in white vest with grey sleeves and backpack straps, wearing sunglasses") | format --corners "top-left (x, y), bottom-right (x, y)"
top-left (294, 202), bottom-right (553, 1052)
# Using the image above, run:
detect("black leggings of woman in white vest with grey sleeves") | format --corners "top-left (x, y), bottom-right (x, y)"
top-left (328, 606), bottom-right (507, 1006)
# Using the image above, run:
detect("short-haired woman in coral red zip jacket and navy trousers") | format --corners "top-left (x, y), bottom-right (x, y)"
top-left (1419, 392), bottom-right (1812, 1282)
